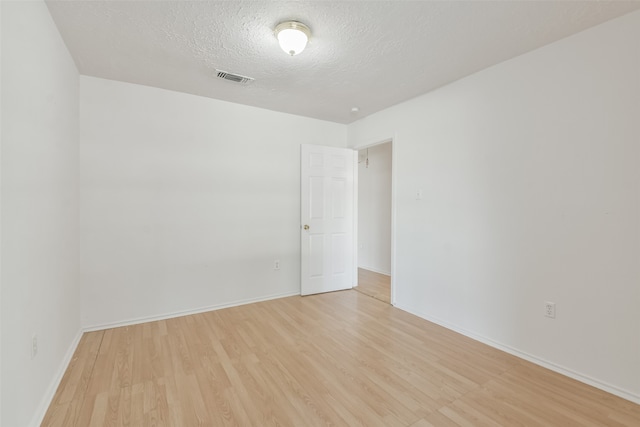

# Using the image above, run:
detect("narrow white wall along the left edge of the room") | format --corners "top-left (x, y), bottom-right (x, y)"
top-left (0, 1), bottom-right (80, 427)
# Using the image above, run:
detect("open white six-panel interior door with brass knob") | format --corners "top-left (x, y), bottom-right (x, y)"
top-left (300, 145), bottom-right (358, 295)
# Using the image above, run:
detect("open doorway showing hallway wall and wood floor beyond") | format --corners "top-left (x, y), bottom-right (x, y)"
top-left (354, 140), bottom-right (393, 304)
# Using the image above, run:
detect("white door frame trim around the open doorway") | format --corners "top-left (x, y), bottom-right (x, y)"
top-left (350, 135), bottom-right (397, 306)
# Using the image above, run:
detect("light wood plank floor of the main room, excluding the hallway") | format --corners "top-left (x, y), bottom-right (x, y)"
top-left (42, 290), bottom-right (640, 427)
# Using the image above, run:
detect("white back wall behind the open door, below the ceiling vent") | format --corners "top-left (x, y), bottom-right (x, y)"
top-left (80, 76), bottom-right (346, 327)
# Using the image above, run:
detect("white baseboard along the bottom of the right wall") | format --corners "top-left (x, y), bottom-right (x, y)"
top-left (395, 305), bottom-right (640, 404)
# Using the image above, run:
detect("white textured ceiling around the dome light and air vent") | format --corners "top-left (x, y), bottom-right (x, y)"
top-left (47, 0), bottom-right (640, 123)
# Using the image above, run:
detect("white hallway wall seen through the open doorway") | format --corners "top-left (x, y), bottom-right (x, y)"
top-left (358, 143), bottom-right (391, 275)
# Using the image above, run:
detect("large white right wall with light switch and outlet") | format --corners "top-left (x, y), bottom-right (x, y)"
top-left (349, 12), bottom-right (640, 402)
